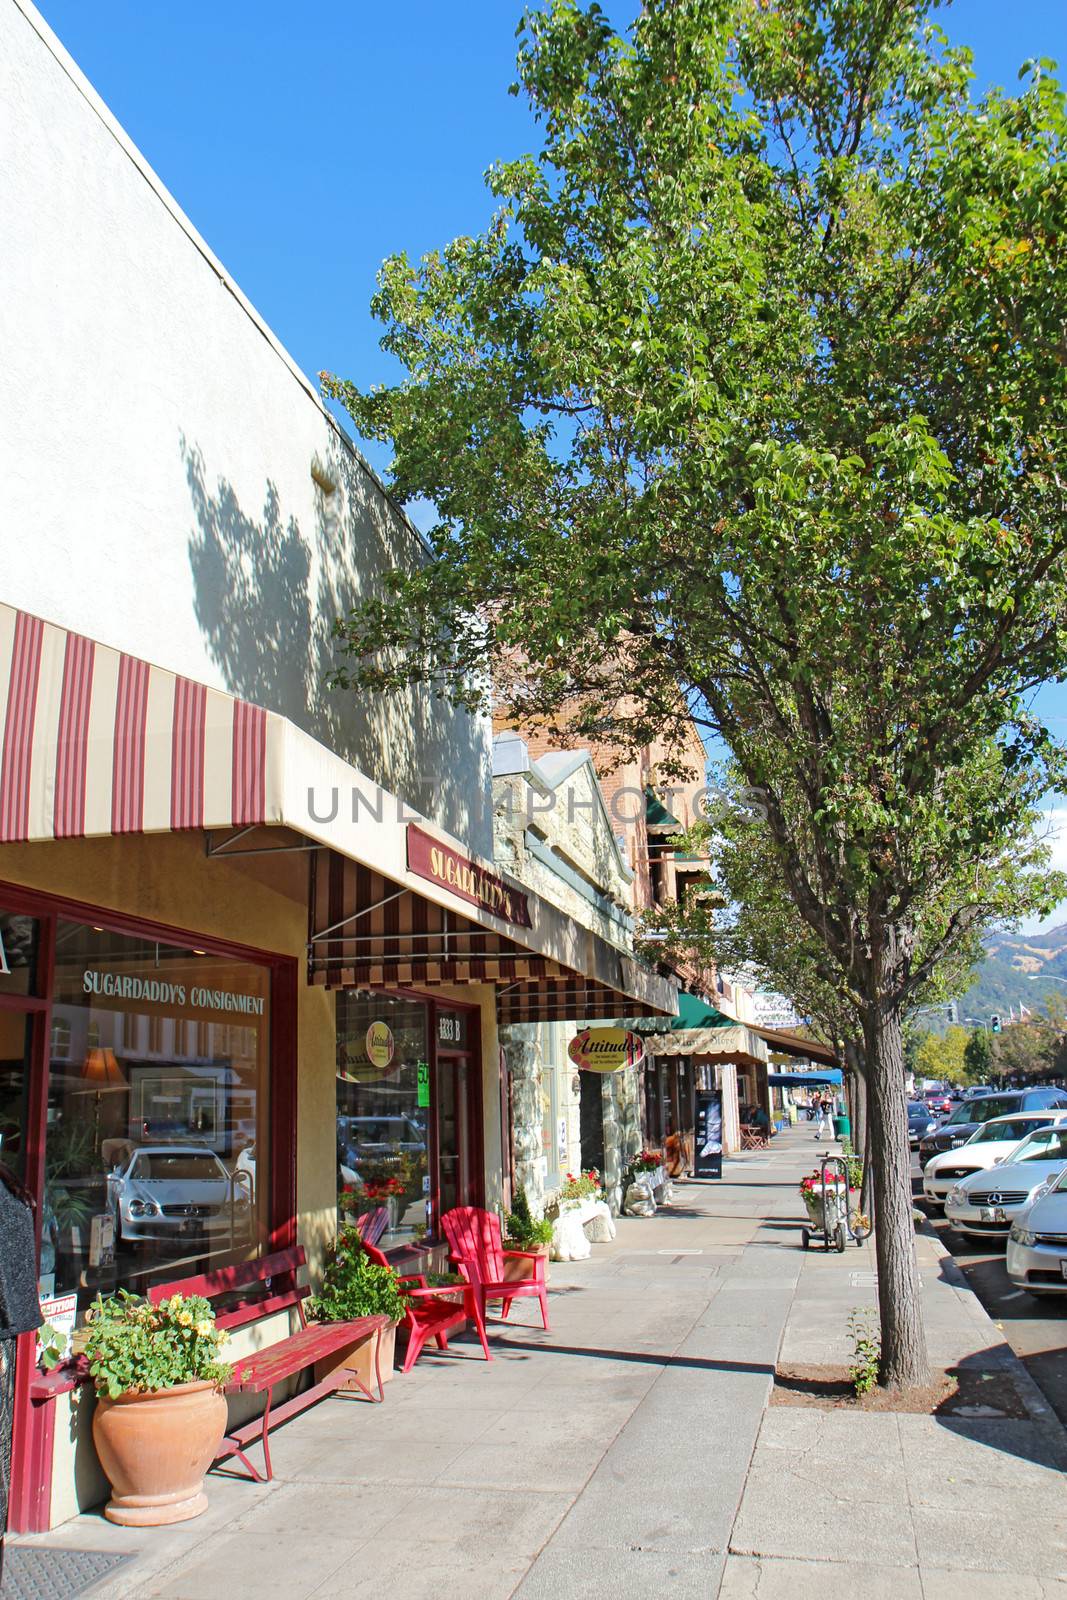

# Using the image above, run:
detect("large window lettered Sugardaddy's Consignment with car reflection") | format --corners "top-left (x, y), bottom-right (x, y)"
top-left (40, 918), bottom-right (270, 1310)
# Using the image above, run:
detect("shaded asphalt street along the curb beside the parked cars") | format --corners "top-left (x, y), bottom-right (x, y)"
top-left (912, 1157), bottom-right (1067, 1422)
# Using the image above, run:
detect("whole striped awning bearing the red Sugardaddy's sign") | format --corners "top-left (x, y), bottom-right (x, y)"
top-left (0, 605), bottom-right (675, 1022)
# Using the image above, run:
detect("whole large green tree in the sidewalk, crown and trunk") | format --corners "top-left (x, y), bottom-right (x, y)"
top-left (325, 0), bottom-right (1067, 1386)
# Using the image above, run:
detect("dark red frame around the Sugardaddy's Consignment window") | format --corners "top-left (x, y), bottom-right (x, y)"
top-left (0, 882), bottom-right (299, 1533)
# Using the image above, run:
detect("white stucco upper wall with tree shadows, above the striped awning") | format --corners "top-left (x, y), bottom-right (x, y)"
top-left (0, 0), bottom-right (491, 856)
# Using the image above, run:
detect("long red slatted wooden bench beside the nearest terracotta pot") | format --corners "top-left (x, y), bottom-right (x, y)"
top-left (149, 1245), bottom-right (389, 1483)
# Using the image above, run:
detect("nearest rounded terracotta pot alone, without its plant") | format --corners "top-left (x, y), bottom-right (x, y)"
top-left (93, 1382), bottom-right (226, 1528)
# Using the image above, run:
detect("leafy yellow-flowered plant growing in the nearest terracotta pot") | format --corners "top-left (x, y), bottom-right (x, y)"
top-left (85, 1290), bottom-right (234, 1400)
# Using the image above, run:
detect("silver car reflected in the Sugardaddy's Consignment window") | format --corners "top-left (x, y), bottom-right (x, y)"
top-left (107, 1144), bottom-right (251, 1245)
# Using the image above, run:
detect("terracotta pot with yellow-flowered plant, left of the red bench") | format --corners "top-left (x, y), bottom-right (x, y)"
top-left (85, 1290), bottom-right (232, 1528)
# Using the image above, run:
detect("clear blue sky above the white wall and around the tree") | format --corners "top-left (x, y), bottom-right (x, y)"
top-left (31, 0), bottom-right (1067, 917)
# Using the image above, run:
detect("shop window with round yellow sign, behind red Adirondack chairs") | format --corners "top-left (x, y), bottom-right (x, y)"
top-left (338, 990), bottom-right (430, 1250)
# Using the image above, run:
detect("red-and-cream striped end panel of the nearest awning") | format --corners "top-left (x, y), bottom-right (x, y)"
top-left (0, 605), bottom-right (285, 843)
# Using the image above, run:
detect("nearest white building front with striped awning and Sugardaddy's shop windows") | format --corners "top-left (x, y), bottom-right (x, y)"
top-left (0, 0), bottom-right (672, 1530)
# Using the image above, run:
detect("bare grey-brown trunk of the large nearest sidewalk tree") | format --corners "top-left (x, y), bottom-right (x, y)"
top-left (864, 1005), bottom-right (929, 1389)
